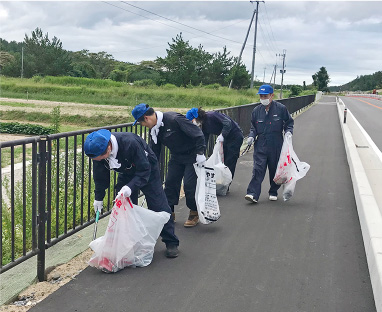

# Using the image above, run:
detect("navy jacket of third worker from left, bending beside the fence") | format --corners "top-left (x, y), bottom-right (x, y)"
top-left (202, 111), bottom-right (242, 144)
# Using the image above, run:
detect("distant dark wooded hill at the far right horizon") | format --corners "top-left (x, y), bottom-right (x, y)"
top-left (329, 71), bottom-right (382, 92)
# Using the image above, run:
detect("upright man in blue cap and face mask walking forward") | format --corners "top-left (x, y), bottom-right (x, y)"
top-left (245, 84), bottom-right (294, 203)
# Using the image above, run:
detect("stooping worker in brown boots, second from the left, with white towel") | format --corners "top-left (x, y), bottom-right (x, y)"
top-left (132, 103), bottom-right (206, 228)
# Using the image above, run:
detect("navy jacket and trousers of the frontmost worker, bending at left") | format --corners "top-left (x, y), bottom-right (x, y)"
top-left (93, 132), bottom-right (179, 246)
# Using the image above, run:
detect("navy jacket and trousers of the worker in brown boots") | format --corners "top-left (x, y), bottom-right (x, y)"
top-left (151, 112), bottom-right (206, 211)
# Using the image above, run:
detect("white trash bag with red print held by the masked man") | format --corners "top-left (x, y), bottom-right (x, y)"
top-left (273, 132), bottom-right (310, 201)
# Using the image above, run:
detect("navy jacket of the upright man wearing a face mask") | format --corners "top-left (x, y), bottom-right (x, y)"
top-left (249, 101), bottom-right (294, 147)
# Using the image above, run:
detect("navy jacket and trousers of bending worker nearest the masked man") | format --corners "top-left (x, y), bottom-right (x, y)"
top-left (202, 112), bottom-right (244, 178)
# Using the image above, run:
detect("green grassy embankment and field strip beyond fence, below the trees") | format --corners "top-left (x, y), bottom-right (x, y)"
top-left (0, 77), bottom-right (268, 127)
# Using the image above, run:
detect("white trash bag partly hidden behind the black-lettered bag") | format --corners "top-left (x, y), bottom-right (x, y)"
top-left (206, 142), bottom-right (232, 196)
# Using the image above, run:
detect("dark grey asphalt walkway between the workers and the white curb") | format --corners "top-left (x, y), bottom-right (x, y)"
top-left (23, 97), bottom-right (376, 312)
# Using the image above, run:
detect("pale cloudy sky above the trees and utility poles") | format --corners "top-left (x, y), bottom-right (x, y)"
top-left (0, 1), bottom-right (382, 86)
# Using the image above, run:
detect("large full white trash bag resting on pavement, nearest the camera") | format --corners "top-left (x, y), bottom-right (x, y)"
top-left (89, 195), bottom-right (170, 273)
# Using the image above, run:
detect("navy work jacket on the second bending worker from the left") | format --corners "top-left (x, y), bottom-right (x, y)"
top-left (151, 112), bottom-right (206, 161)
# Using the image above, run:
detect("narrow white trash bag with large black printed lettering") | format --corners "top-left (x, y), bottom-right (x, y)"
top-left (194, 164), bottom-right (220, 224)
